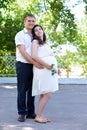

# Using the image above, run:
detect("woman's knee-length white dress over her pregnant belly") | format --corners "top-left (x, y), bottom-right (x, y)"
top-left (32, 44), bottom-right (58, 96)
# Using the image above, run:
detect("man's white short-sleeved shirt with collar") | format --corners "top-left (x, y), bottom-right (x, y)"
top-left (15, 28), bottom-right (32, 63)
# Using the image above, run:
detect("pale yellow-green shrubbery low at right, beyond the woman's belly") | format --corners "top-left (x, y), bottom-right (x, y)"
top-left (56, 52), bottom-right (87, 77)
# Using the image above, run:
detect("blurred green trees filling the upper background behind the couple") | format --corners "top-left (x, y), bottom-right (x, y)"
top-left (0, 0), bottom-right (87, 74)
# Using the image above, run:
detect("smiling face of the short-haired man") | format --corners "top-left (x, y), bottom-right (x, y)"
top-left (24, 16), bottom-right (36, 30)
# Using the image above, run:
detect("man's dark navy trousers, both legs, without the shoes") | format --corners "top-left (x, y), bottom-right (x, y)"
top-left (16, 62), bottom-right (35, 115)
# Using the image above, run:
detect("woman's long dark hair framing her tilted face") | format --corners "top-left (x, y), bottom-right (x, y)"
top-left (32, 25), bottom-right (46, 45)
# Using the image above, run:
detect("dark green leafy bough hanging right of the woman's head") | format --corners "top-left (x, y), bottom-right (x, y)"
top-left (50, 0), bottom-right (77, 44)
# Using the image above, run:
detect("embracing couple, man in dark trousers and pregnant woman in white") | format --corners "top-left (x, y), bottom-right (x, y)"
top-left (15, 14), bottom-right (59, 123)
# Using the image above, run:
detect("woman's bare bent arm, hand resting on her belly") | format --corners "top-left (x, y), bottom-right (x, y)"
top-left (31, 40), bottom-right (52, 70)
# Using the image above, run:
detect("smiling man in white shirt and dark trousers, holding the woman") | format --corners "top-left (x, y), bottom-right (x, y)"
top-left (15, 14), bottom-right (41, 122)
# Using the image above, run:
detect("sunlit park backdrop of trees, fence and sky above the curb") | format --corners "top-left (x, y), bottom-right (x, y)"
top-left (0, 0), bottom-right (87, 78)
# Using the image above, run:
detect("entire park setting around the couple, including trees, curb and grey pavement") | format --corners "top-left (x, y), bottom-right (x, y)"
top-left (0, 0), bottom-right (87, 130)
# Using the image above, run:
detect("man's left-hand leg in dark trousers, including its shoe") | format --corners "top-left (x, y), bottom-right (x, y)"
top-left (16, 62), bottom-right (27, 122)
